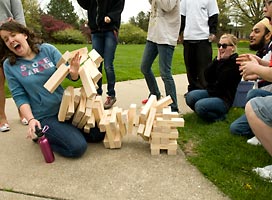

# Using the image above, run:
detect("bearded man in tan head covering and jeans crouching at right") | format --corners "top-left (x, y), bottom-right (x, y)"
top-left (230, 18), bottom-right (272, 141)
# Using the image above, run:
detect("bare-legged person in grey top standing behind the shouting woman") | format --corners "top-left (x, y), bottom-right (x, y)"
top-left (0, 0), bottom-right (26, 132)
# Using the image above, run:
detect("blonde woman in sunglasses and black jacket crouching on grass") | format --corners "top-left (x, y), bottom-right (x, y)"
top-left (185, 34), bottom-right (241, 122)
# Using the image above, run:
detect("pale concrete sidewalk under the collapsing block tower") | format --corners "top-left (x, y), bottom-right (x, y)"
top-left (0, 75), bottom-right (229, 200)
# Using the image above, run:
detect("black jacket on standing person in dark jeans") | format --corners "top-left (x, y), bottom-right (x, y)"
top-left (77, 0), bottom-right (125, 33)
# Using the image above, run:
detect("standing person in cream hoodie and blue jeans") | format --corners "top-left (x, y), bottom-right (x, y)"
top-left (141, 0), bottom-right (180, 112)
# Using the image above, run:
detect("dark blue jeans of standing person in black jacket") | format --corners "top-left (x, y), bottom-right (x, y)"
top-left (92, 31), bottom-right (118, 96)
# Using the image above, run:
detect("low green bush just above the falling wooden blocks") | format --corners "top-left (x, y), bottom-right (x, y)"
top-left (52, 28), bottom-right (87, 44)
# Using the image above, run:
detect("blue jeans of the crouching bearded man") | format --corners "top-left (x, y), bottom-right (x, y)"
top-left (230, 89), bottom-right (272, 137)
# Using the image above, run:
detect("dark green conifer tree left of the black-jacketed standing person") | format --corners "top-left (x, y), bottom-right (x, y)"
top-left (47, 0), bottom-right (79, 28)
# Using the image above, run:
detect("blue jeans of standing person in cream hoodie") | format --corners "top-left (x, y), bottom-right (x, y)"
top-left (141, 41), bottom-right (179, 112)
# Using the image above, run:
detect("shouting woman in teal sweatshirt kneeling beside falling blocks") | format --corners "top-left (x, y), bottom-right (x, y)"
top-left (0, 21), bottom-right (105, 157)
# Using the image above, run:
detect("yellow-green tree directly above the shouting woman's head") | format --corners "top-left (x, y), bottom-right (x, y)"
top-left (22, 0), bottom-right (42, 33)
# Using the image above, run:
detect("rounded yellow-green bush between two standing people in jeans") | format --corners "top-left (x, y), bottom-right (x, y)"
top-left (119, 24), bottom-right (147, 44)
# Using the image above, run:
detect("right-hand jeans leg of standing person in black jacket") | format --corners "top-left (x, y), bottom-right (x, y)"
top-left (104, 31), bottom-right (118, 97)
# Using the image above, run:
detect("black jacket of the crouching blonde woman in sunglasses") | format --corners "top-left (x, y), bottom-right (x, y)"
top-left (205, 53), bottom-right (242, 108)
